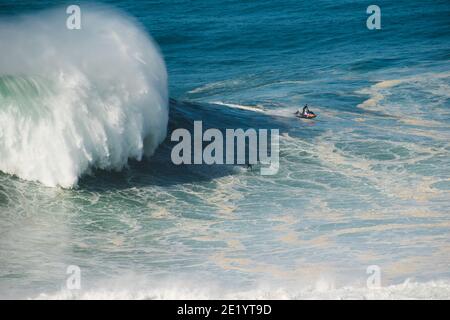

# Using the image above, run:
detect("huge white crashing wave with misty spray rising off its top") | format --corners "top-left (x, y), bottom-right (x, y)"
top-left (0, 7), bottom-right (168, 188)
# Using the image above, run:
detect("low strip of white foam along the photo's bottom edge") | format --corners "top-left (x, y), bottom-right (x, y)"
top-left (33, 279), bottom-right (450, 300)
